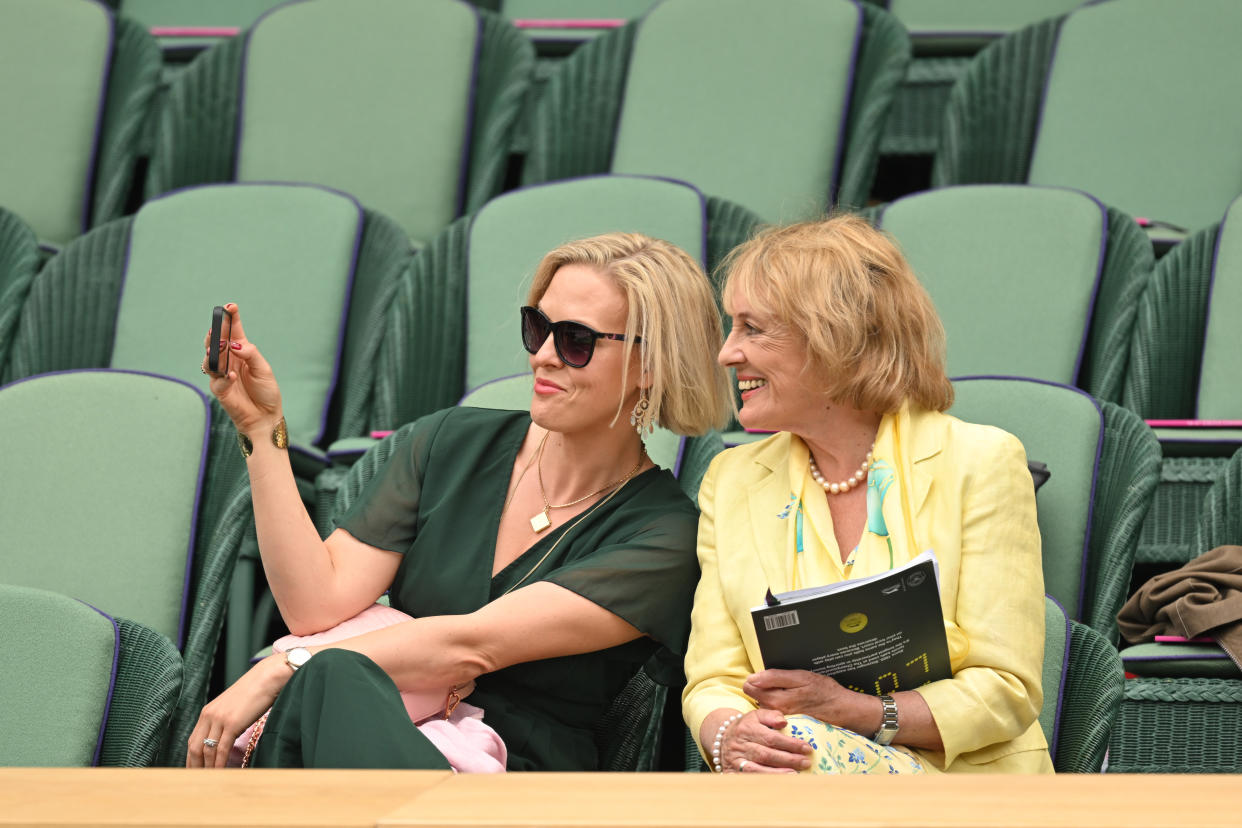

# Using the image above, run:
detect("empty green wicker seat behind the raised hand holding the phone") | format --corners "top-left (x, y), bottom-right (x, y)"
top-left (6, 184), bottom-right (410, 705)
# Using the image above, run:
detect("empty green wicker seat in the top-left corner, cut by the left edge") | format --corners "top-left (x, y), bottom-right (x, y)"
top-left (0, 0), bottom-right (160, 245)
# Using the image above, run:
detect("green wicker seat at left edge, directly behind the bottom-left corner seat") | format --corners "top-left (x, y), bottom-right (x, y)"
top-left (0, 370), bottom-right (250, 765)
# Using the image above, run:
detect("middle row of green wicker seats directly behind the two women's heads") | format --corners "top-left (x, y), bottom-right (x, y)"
top-left (0, 176), bottom-right (1242, 431)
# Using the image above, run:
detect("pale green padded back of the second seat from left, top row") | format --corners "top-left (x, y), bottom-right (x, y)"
top-left (235, 0), bottom-right (481, 242)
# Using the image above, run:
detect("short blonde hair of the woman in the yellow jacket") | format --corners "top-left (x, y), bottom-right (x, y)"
top-left (722, 214), bottom-right (953, 413)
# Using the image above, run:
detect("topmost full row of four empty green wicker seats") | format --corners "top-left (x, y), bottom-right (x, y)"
top-left (9, 0), bottom-right (1242, 253)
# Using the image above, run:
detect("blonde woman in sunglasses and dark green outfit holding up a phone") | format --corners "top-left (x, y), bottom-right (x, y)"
top-left (188, 233), bottom-right (729, 770)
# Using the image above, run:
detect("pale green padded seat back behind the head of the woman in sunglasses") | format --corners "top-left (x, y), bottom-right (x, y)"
top-left (466, 175), bottom-right (707, 392)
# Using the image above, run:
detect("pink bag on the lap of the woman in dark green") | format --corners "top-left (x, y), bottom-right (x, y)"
top-left (229, 603), bottom-right (508, 773)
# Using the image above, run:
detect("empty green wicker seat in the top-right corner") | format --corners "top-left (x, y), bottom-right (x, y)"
top-left (933, 0), bottom-right (1242, 245)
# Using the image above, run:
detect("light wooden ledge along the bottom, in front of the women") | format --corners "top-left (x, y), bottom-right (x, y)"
top-left (0, 768), bottom-right (1242, 828)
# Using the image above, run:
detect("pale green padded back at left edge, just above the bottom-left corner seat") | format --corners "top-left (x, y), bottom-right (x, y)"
top-left (0, 371), bottom-right (210, 647)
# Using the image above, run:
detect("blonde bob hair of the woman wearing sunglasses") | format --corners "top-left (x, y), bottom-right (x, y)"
top-left (527, 233), bottom-right (732, 436)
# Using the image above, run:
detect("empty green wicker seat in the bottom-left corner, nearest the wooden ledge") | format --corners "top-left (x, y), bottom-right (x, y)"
top-left (0, 583), bottom-right (181, 767)
